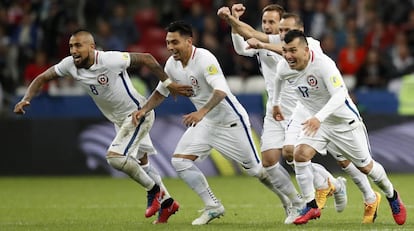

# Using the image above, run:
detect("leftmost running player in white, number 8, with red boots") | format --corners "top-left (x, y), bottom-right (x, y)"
top-left (14, 30), bottom-right (192, 223)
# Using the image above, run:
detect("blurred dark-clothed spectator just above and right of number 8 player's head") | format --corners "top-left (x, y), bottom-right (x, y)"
top-left (109, 3), bottom-right (139, 46)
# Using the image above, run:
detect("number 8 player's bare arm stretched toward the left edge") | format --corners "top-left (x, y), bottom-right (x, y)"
top-left (13, 66), bottom-right (59, 114)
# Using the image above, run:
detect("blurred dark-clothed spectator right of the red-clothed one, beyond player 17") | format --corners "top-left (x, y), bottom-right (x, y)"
top-left (356, 49), bottom-right (390, 89)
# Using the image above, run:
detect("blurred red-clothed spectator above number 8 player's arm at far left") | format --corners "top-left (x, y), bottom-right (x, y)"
top-left (23, 50), bottom-right (51, 93)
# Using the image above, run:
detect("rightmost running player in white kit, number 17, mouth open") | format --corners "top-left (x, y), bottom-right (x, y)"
top-left (273, 30), bottom-right (407, 225)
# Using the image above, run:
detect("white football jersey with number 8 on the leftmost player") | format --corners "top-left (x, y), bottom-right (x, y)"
top-left (54, 50), bottom-right (146, 127)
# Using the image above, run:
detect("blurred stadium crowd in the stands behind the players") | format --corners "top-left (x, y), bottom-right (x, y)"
top-left (0, 0), bottom-right (414, 114)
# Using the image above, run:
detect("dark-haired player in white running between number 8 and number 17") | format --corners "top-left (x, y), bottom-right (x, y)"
top-left (133, 21), bottom-right (270, 225)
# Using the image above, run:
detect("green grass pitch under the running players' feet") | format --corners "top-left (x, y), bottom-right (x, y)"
top-left (0, 174), bottom-right (414, 231)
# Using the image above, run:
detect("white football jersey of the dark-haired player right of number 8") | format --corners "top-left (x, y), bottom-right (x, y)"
top-left (156, 46), bottom-right (250, 126)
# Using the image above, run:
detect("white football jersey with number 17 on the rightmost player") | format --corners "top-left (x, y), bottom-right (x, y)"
top-left (277, 50), bottom-right (361, 125)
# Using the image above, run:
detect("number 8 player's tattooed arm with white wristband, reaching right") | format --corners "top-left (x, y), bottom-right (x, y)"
top-left (130, 53), bottom-right (193, 97)
